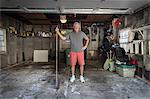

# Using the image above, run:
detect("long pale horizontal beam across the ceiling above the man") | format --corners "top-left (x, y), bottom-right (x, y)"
top-left (0, 7), bottom-right (131, 14)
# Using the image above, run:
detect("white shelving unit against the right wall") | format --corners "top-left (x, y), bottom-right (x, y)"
top-left (132, 25), bottom-right (150, 79)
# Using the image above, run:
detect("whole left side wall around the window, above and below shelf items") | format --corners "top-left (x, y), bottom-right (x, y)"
top-left (0, 14), bottom-right (24, 67)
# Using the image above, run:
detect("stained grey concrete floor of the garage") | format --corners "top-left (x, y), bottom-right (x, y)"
top-left (0, 64), bottom-right (150, 99)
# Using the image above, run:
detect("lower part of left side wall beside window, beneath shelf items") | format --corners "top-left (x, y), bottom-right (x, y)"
top-left (0, 33), bottom-right (23, 67)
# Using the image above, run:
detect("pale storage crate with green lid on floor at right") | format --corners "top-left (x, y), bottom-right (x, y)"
top-left (115, 64), bottom-right (136, 77)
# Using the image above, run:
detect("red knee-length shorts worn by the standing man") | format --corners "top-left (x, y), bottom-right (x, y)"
top-left (70, 51), bottom-right (85, 66)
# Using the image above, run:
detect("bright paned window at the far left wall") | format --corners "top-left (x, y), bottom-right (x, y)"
top-left (0, 29), bottom-right (6, 52)
